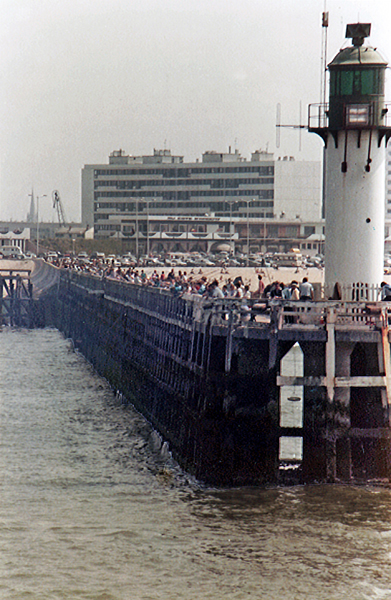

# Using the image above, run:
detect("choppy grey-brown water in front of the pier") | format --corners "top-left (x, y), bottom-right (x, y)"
top-left (0, 329), bottom-right (391, 600)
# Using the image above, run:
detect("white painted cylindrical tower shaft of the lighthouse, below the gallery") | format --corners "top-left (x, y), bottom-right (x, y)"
top-left (325, 130), bottom-right (385, 290)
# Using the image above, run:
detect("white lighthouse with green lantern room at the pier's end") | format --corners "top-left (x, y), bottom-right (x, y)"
top-left (309, 23), bottom-right (391, 300)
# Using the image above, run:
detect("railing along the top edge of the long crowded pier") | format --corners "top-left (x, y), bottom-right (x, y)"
top-left (61, 271), bottom-right (391, 329)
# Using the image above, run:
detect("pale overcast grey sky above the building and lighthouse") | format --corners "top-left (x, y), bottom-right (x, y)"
top-left (0, 0), bottom-right (391, 221)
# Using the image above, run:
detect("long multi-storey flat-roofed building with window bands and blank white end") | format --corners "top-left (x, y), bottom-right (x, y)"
top-left (82, 150), bottom-right (321, 245)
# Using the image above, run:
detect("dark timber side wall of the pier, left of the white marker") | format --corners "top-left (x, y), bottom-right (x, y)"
top-left (51, 273), bottom-right (279, 485)
